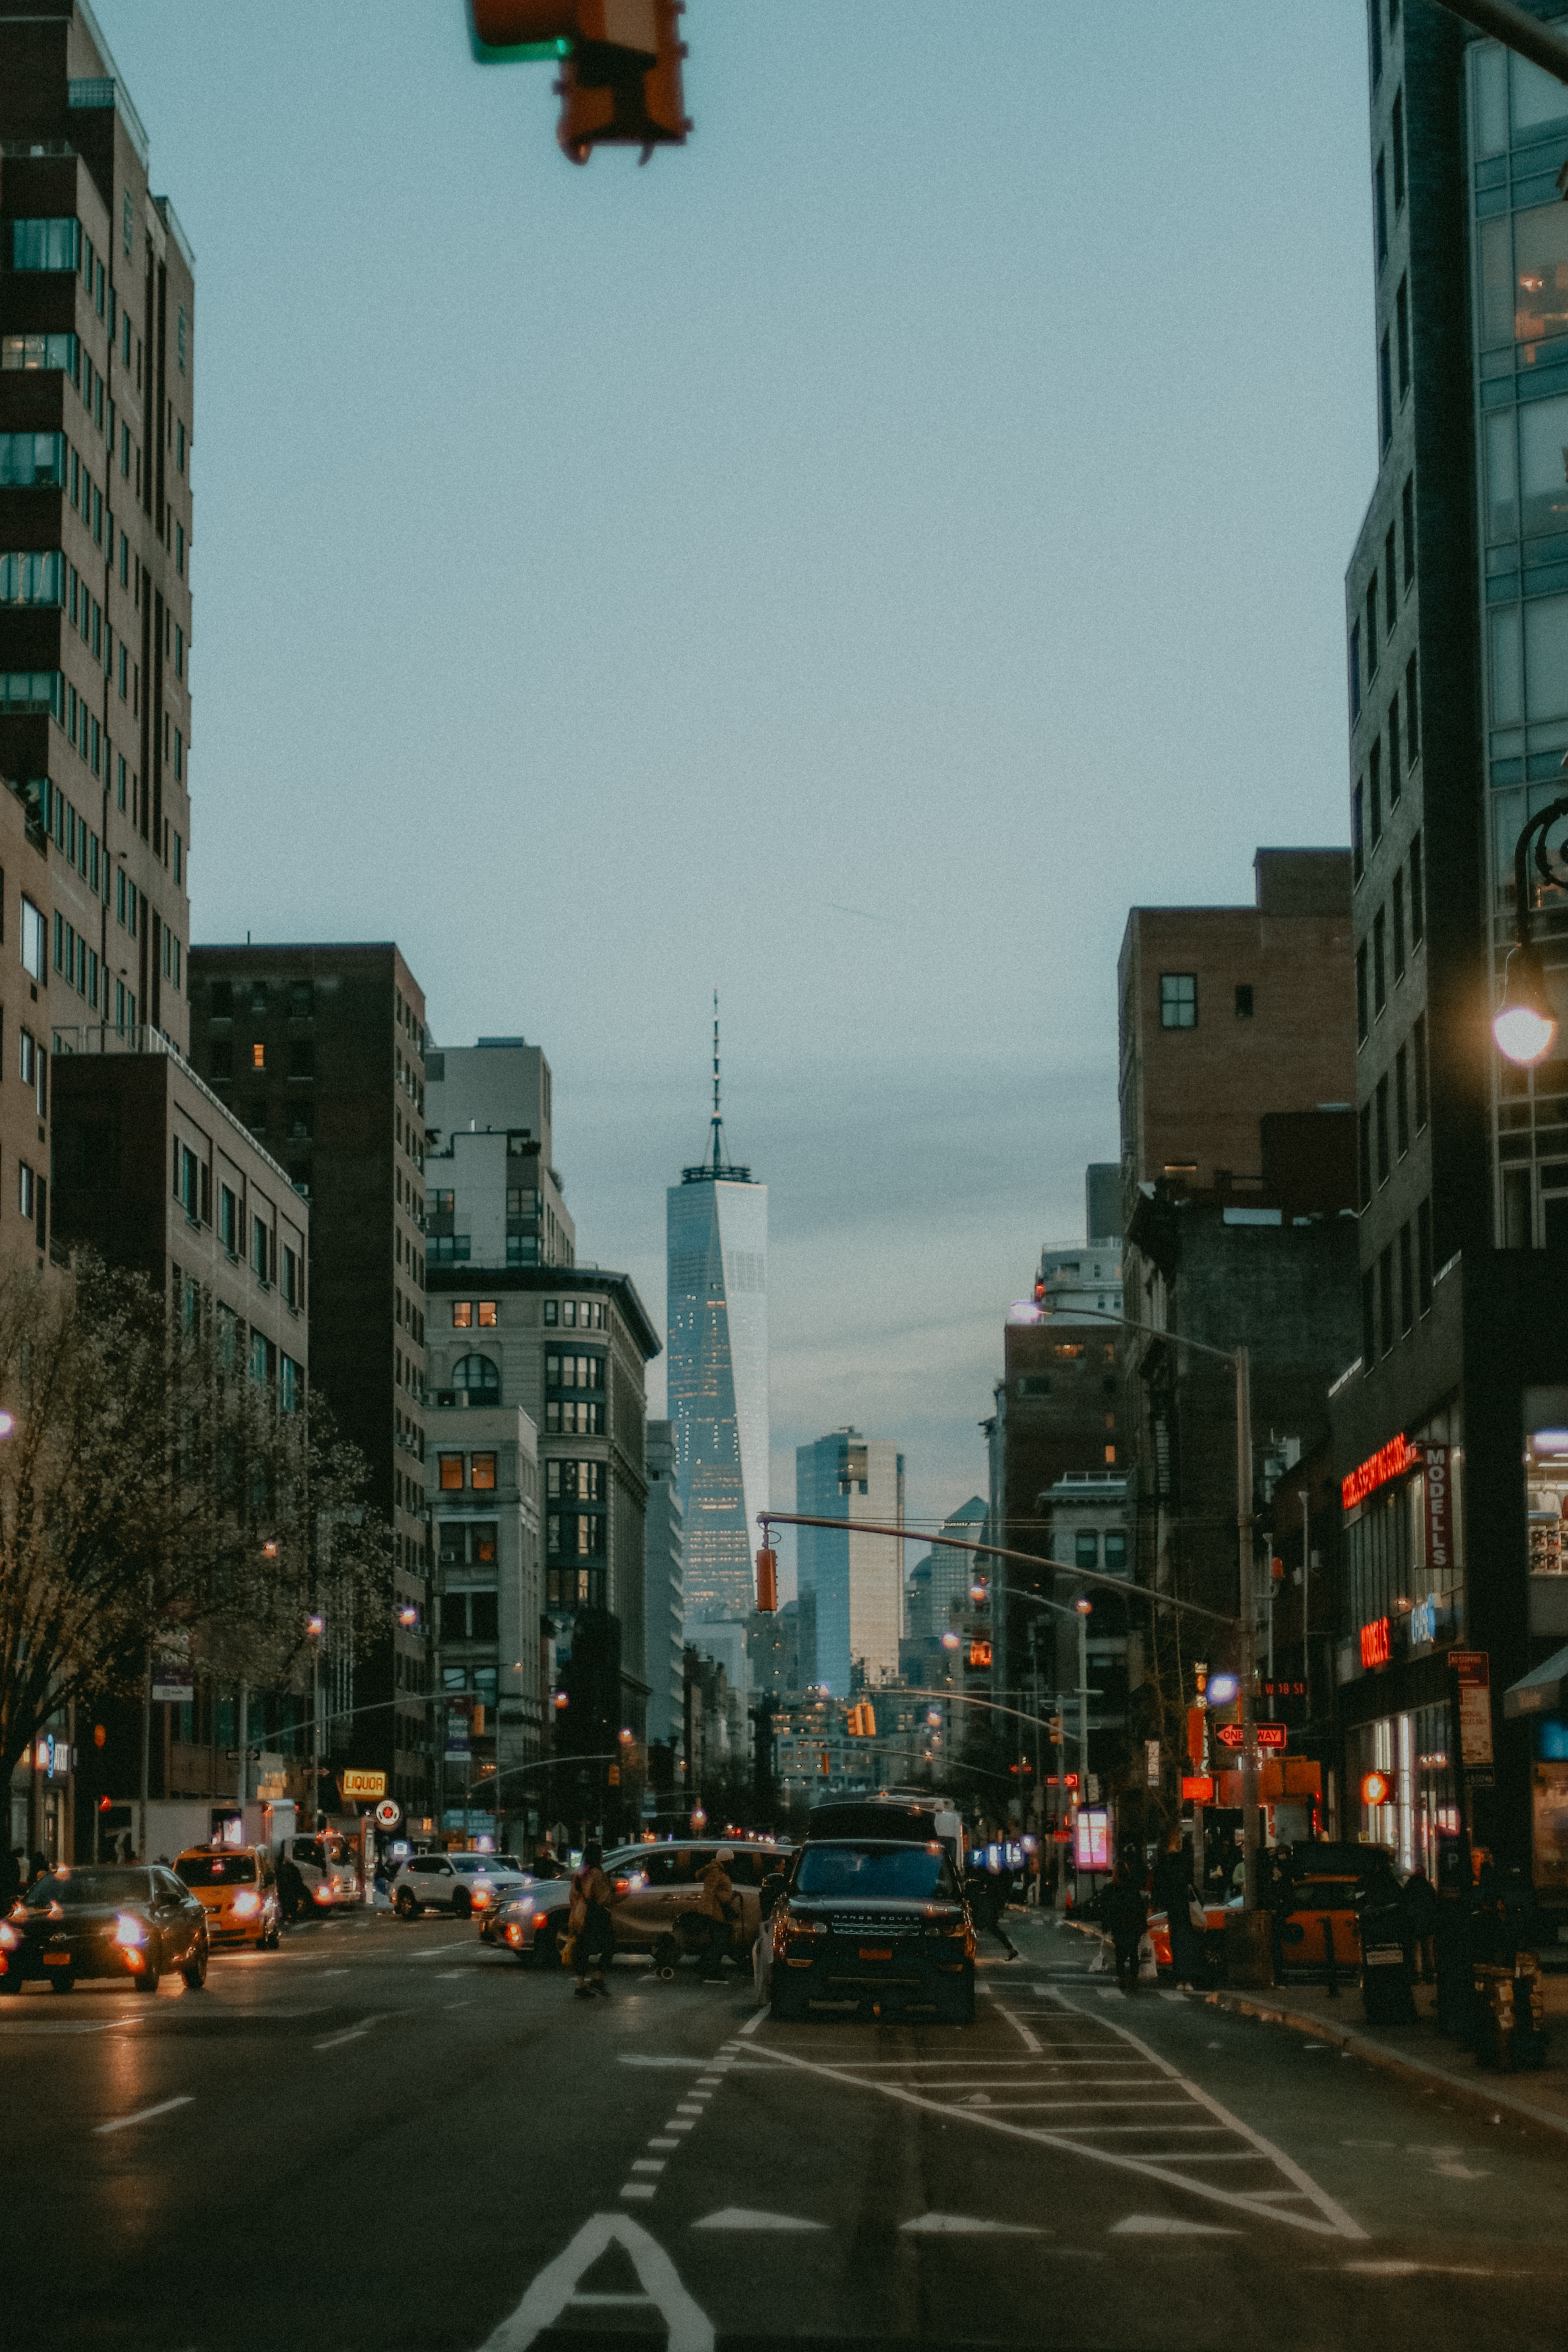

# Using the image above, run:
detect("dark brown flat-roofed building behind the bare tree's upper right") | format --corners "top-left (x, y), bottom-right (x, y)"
top-left (190, 943), bottom-right (435, 1830)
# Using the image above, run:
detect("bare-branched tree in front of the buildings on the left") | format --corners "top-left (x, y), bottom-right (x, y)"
top-left (0, 1256), bottom-right (393, 1790)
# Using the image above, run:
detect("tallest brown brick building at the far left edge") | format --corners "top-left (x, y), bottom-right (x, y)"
top-left (0, 0), bottom-right (195, 1265)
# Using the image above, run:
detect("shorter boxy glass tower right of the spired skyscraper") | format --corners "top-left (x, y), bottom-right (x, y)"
top-left (794, 1427), bottom-right (903, 1698)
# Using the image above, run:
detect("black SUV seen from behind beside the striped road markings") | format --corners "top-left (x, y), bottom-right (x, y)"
top-left (769, 1837), bottom-right (976, 2025)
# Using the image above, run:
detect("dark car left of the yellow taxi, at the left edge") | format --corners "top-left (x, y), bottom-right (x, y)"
top-left (0, 1863), bottom-right (207, 1992)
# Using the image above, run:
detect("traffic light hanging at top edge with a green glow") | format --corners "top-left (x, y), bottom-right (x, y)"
top-left (470, 0), bottom-right (691, 162)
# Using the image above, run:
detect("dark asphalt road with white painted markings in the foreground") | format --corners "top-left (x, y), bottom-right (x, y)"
top-left (0, 1915), bottom-right (1568, 2352)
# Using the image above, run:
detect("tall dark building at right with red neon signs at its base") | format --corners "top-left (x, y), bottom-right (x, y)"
top-left (1333, 0), bottom-right (1568, 1905)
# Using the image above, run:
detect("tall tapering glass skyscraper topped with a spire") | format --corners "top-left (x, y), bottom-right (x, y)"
top-left (665, 997), bottom-right (769, 1625)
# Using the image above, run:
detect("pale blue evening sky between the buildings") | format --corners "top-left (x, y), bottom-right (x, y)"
top-left (94, 0), bottom-right (1375, 1583)
